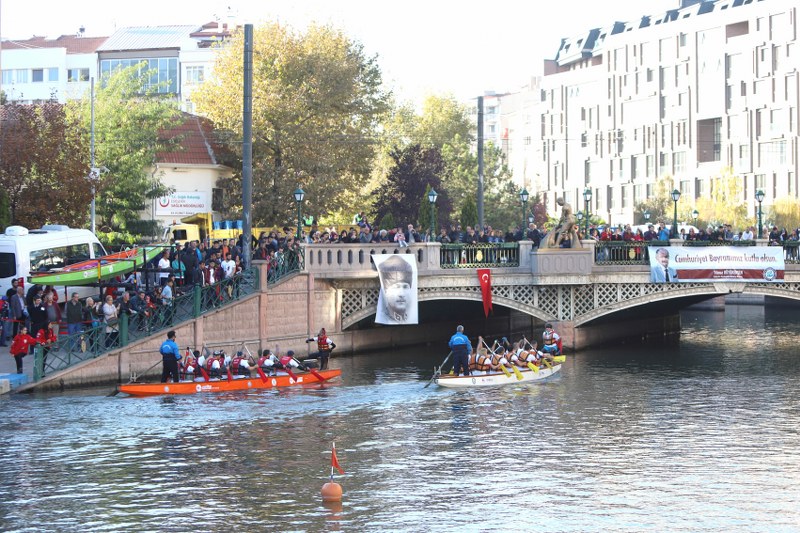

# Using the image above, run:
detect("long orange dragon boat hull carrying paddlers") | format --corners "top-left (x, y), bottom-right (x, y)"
top-left (117, 368), bottom-right (342, 396)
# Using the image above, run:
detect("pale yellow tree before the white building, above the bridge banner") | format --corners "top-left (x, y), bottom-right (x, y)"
top-left (692, 168), bottom-right (752, 228)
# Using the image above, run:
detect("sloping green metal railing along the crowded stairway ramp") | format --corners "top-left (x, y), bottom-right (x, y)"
top-left (33, 268), bottom-right (259, 381)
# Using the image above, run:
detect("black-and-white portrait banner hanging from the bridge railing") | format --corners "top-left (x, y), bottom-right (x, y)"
top-left (372, 254), bottom-right (419, 326)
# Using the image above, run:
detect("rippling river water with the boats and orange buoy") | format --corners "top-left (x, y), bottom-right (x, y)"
top-left (0, 306), bottom-right (800, 532)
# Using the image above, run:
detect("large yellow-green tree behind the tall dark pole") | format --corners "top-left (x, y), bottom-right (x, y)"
top-left (192, 23), bottom-right (388, 224)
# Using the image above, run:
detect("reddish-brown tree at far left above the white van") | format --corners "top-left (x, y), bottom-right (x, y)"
top-left (0, 102), bottom-right (91, 228)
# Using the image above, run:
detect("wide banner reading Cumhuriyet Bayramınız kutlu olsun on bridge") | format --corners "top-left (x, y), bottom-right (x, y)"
top-left (648, 246), bottom-right (785, 283)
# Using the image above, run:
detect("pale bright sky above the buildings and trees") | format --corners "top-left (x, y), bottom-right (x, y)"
top-left (0, 0), bottom-right (679, 105)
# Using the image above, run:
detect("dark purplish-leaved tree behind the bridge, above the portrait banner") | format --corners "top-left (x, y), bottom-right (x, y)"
top-left (374, 144), bottom-right (450, 229)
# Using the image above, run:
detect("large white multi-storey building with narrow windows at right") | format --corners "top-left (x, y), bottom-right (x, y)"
top-left (502, 0), bottom-right (800, 223)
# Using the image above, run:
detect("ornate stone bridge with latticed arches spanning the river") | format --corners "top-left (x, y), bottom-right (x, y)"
top-left (305, 240), bottom-right (800, 344)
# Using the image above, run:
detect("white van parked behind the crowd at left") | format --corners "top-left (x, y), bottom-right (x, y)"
top-left (0, 225), bottom-right (106, 302)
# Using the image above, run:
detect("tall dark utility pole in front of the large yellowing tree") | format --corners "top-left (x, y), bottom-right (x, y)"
top-left (242, 24), bottom-right (253, 267)
